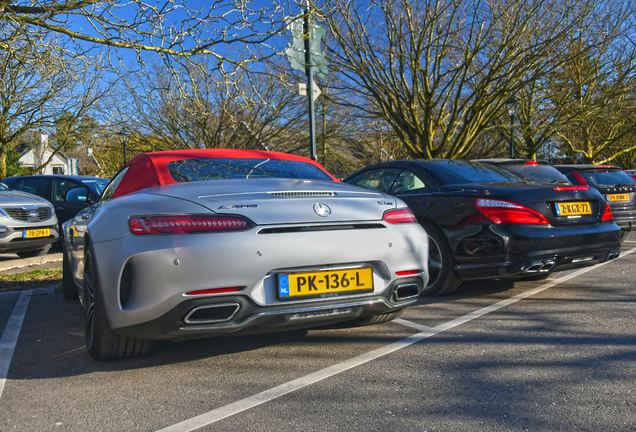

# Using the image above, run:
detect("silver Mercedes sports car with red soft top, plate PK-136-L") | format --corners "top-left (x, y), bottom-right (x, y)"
top-left (63, 149), bottom-right (428, 360)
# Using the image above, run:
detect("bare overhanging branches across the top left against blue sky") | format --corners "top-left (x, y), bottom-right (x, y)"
top-left (0, 0), bottom-right (283, 79)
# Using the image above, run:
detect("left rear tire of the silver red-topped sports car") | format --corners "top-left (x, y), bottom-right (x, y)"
top-left (82, 246), bottom-right (154, 360)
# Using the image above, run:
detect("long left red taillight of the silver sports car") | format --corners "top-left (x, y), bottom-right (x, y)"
top-left (129, 215), bottom-right (254, 235)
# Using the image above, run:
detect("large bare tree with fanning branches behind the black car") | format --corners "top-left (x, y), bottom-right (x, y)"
top-left (316, 0), bottom-right (593, 158)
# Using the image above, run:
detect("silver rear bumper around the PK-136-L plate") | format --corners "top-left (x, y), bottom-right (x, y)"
top-left (87, 224), bottom-right (428, 339)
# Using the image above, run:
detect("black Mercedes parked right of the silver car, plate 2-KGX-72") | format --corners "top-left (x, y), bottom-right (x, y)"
top-left (344, 159), bottom-right (620, 295)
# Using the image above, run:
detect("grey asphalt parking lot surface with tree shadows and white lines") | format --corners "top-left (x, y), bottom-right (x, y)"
top-left (0, 235), bottom-right (636, 431)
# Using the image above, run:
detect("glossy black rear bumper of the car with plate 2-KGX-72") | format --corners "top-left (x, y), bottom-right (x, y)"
top-left (455, 222), bottom-right (620, 280)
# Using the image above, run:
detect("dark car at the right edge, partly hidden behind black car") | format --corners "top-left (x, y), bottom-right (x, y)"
top-left (555, 164), bottom-right (636, 241)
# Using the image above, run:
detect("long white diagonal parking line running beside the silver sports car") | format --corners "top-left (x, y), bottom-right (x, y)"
top-left (158, 248), bottom-right (636, 432)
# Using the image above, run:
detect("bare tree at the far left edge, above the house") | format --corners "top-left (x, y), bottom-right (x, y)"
top-left (0, 28), bottom-right (108, 178)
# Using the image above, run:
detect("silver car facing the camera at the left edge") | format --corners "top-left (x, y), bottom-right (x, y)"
top-left (0, 184), bottom-right (59, 258)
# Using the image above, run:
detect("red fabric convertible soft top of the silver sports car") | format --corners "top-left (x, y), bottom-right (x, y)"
top-left (113, 149), bottom-right (338, 198)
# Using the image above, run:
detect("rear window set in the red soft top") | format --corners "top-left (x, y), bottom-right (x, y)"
top-left (168, 158), bottom-right (333, 182)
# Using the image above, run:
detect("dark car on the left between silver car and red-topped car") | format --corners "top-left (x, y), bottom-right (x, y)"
top-left (3, 175), bottom-right (108, 238)
